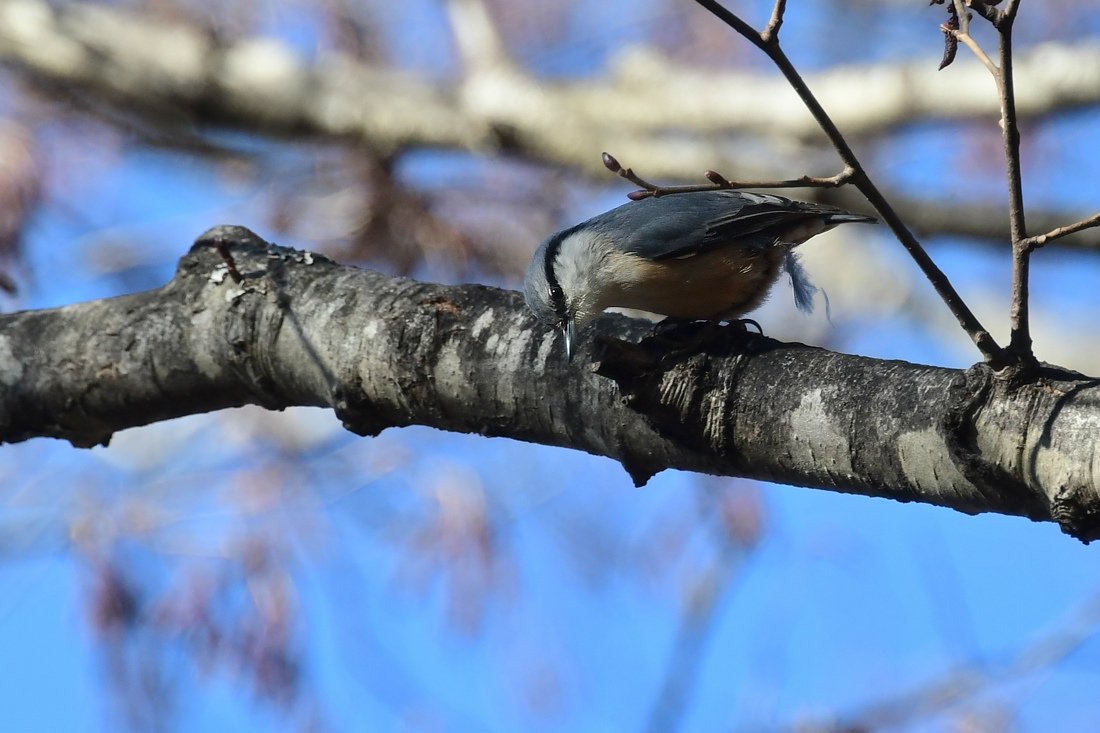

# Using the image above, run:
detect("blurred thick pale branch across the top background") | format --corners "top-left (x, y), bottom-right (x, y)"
top-left (0, 0), bottom-right (1100, 149)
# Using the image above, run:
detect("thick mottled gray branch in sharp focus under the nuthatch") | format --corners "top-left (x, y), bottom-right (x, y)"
top-left (0, 227), bottom-right (1100, 540)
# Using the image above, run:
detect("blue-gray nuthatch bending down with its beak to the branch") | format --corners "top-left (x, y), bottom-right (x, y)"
top-left (524, 190), bottom-right (875, 359)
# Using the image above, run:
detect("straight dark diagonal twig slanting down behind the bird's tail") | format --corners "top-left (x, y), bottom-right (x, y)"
top-left (695, 0), bottom-right (1004, 367)
